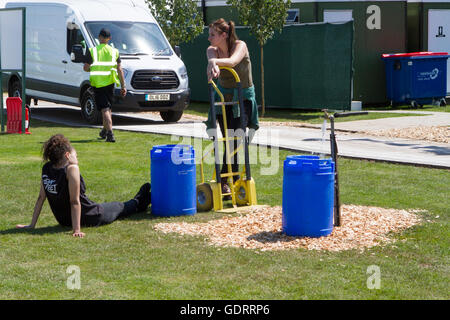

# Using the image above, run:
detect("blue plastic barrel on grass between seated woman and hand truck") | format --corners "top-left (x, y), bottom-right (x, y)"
top-left (150, 144), bottom-right (197, 217)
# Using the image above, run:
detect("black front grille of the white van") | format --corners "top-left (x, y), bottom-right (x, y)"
top-left (131, 70), bottom-right (180, 90)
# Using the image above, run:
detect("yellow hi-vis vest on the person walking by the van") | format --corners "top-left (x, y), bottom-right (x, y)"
top-left (89, 43), bottom-right (120, 88)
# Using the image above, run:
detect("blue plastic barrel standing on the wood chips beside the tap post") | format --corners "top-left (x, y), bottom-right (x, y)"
top-left (282, 155), bottom-right (334, 237)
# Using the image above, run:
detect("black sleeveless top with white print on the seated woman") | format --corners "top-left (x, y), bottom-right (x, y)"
top-left (42, 162), bottom-right (103, 227)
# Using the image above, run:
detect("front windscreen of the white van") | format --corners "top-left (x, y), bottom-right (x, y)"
top-left (86, 21), bottom-right (172, 56)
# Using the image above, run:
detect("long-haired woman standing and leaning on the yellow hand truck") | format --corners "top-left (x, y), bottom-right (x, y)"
top-left (206, 18), bottom-right (259, 193)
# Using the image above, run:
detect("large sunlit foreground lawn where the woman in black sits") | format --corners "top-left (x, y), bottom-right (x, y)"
top-left (0, 120), bottom-right (450, 299)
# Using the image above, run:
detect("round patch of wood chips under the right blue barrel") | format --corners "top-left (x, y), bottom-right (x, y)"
top-left (154, 205), bottom-right (424, 251)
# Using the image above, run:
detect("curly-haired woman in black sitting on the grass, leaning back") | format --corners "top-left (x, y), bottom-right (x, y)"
top-left (16, 134), bottom-right (151, 238)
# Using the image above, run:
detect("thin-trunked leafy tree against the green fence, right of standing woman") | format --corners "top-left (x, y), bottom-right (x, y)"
top-left (227, 0), bottom-right (291, 116)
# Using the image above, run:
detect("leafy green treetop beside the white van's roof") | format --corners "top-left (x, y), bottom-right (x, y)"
top-left (145, 0), bottom-right (203, 46)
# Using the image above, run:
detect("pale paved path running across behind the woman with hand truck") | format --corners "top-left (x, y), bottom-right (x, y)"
top-left (16, 102), bottom-right (450, 169)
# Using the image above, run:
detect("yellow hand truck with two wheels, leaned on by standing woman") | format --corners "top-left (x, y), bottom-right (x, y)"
top-left (197, 67), bottom-right (257, 211)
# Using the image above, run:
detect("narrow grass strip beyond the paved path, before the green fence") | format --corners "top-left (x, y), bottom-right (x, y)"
top-left (184, 102), bottom-right (430, 124)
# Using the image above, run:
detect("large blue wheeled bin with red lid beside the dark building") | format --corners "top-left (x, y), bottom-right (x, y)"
top-left (382, 52), bottom-right (449, 106)
